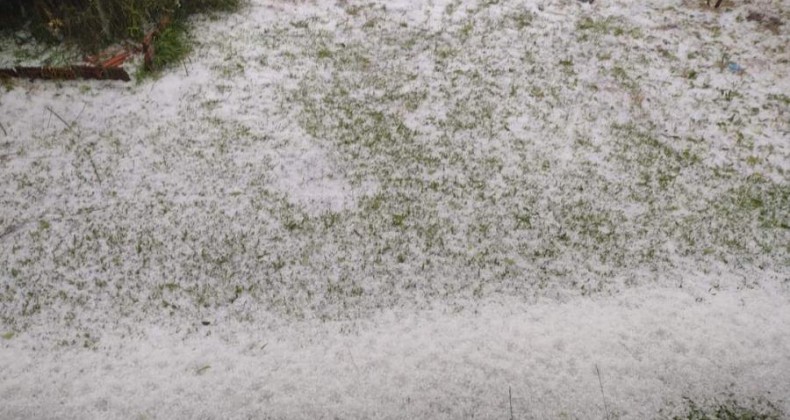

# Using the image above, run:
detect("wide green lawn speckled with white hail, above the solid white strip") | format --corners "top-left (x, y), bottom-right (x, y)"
top-left (0, 3), bottom-right (790, 342)
